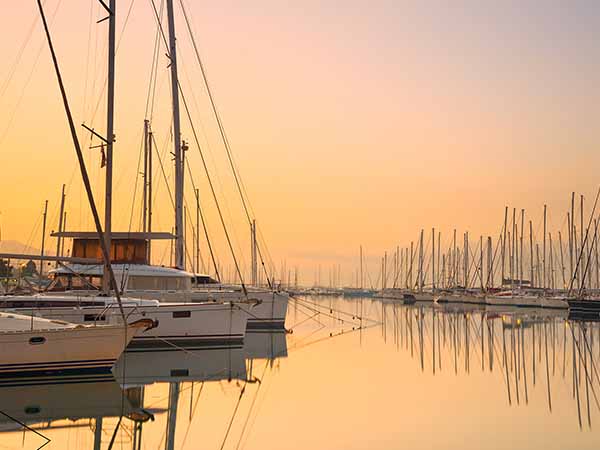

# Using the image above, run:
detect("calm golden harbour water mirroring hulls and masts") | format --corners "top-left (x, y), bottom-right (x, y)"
top-left (0, 297), bottom-right (600, 450)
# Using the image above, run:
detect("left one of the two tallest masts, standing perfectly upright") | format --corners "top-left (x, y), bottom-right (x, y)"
top-left (102, 0), bottom-right (117, 295)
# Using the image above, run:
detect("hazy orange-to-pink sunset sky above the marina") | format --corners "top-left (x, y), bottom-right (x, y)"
top-left (0, 0), bottom-right (600, 281)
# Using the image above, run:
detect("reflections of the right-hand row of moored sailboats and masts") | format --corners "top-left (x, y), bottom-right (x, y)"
top-left (381, 304), bottom-right (600, 428)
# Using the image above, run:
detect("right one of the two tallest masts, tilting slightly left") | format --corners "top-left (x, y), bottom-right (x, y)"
top-left (167, 0), bottom-right (184, 269)
